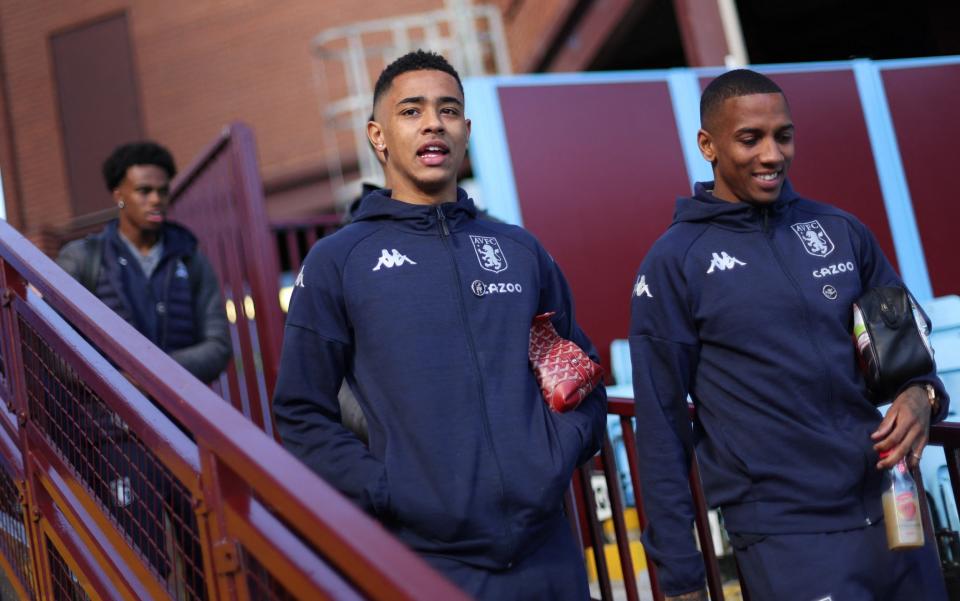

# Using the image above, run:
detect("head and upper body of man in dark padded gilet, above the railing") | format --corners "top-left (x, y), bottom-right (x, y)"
top-left (57, 142), bottom-right (230, 382)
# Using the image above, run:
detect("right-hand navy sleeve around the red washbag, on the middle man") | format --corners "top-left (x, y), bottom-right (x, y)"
top-left (537, 245), bottom-right (607, 465)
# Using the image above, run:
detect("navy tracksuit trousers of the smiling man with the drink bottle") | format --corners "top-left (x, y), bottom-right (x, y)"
top-left (730, 520), bottom-right (947, 601)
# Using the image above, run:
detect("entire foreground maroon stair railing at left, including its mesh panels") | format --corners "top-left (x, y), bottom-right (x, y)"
top-left (0, 202), bottom-right (463, 599)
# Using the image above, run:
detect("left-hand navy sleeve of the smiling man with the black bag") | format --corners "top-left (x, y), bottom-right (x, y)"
top-left (630, 249), bottom-right (704, 595)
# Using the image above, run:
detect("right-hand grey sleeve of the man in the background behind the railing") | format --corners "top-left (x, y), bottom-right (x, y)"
top-left (170, 252), bottom-right (231, 383)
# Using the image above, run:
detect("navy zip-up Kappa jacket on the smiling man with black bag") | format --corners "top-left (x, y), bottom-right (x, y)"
top-left (630, 182), bottom-right (948, 594)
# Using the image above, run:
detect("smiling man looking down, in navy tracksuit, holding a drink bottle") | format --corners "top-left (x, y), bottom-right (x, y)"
top-left (630, 70), bottom-right (948, 601)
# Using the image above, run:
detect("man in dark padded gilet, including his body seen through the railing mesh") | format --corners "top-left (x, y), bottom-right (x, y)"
top-left (55, 142), bottom-right (231, 597)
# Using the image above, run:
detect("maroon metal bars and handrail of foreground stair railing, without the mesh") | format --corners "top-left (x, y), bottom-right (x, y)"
top-left (0, 175), bottom-right (464, 599)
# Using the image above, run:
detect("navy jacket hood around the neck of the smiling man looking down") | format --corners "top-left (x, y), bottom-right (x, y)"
top-left (673, 180), bottom-right (800, 230)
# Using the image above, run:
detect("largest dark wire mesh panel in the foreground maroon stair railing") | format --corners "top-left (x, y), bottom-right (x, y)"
top-left (19, 318), bottom-right (206, 600)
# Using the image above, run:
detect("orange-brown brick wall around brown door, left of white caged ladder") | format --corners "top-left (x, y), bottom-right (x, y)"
top-left (0, 0), bottom-right (460, 240)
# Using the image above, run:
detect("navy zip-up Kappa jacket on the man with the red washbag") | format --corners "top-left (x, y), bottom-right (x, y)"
top-left (273, 190), bottom-right (606, 569)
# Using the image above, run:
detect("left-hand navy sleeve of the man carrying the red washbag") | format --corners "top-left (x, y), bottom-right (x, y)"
top-left (273, 253), bottom-right (389, 517)
